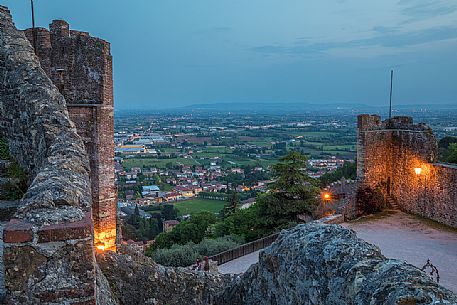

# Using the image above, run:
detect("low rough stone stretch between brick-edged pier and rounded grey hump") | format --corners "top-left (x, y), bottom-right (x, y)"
top-left (97, 252), bottom-right (233, 305)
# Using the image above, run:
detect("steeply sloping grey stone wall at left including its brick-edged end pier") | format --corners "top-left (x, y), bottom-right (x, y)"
top-left (0, 6), bottom-right (96, 304)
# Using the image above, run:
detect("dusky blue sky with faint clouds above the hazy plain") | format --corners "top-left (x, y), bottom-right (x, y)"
top-left (0, 0), bottom-right (457, 109)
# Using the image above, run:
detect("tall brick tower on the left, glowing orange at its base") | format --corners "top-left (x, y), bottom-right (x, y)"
top-left (25, 20), bottom-right (117, 250)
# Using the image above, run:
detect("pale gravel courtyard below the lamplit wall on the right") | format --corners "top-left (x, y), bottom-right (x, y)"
top-left (343, 212), bottom-right (457, 293)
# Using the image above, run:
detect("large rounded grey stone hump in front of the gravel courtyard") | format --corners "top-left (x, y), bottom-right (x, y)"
top-left (217, 224), bottom-right (457, 305)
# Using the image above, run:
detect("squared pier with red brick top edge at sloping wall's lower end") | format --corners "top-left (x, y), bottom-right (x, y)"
top-left (3, 213), bottom-right (95, 304)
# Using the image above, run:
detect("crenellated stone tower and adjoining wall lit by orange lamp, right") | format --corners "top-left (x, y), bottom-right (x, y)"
top-left (357, 115), bottom-right (457, 227)
